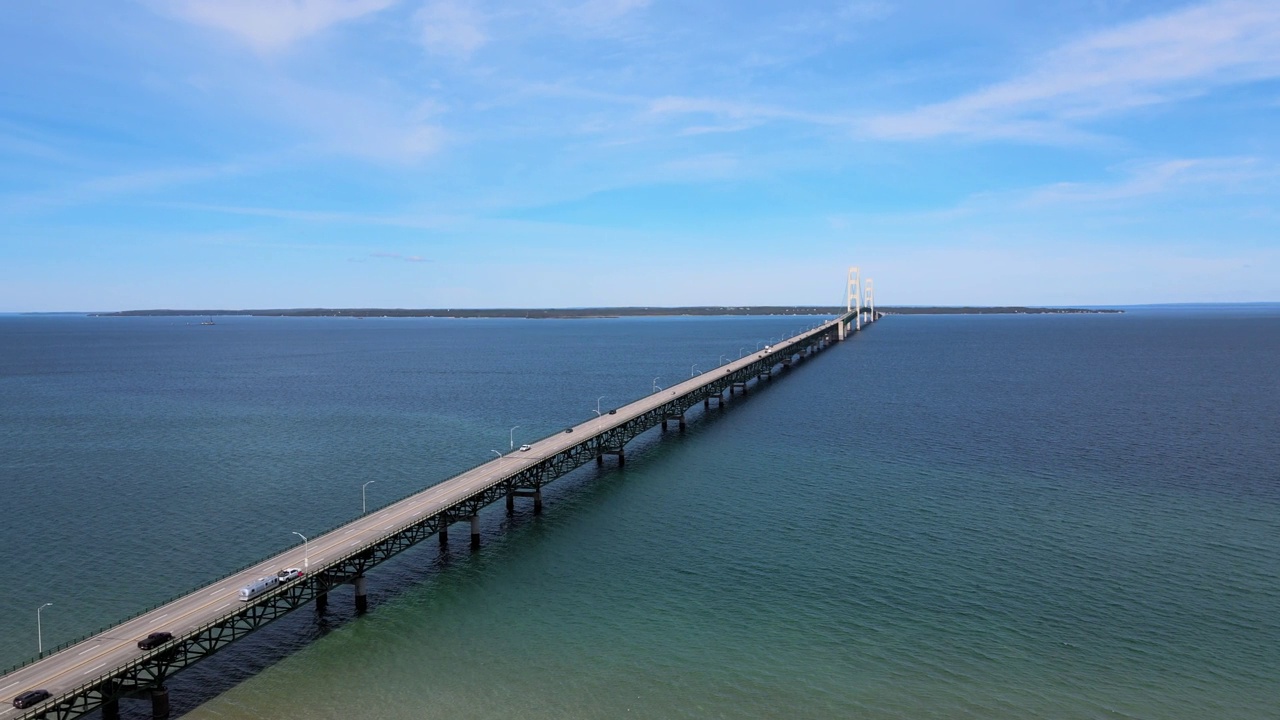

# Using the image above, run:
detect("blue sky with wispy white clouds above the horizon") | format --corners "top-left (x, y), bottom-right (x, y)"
top-left (0, 0), bottom-right (1280, 311)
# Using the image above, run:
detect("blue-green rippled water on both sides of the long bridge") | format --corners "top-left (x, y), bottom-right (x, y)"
top-left (0, 307), bottom-right (1280, 719)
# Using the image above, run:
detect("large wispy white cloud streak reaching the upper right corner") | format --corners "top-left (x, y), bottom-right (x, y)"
top-left (863, 0), bottom-right (1280, 141)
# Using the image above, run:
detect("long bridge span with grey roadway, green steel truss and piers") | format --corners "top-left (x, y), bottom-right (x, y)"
top-left (0, 313), bottom-right (873, 720)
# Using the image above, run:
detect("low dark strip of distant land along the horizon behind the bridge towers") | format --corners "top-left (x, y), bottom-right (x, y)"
top-left (88, 305), bottom-right (1124, 319)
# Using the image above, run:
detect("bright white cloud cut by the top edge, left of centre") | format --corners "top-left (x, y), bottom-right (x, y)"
top-left (160, 0), bottom-right (397, 53)
